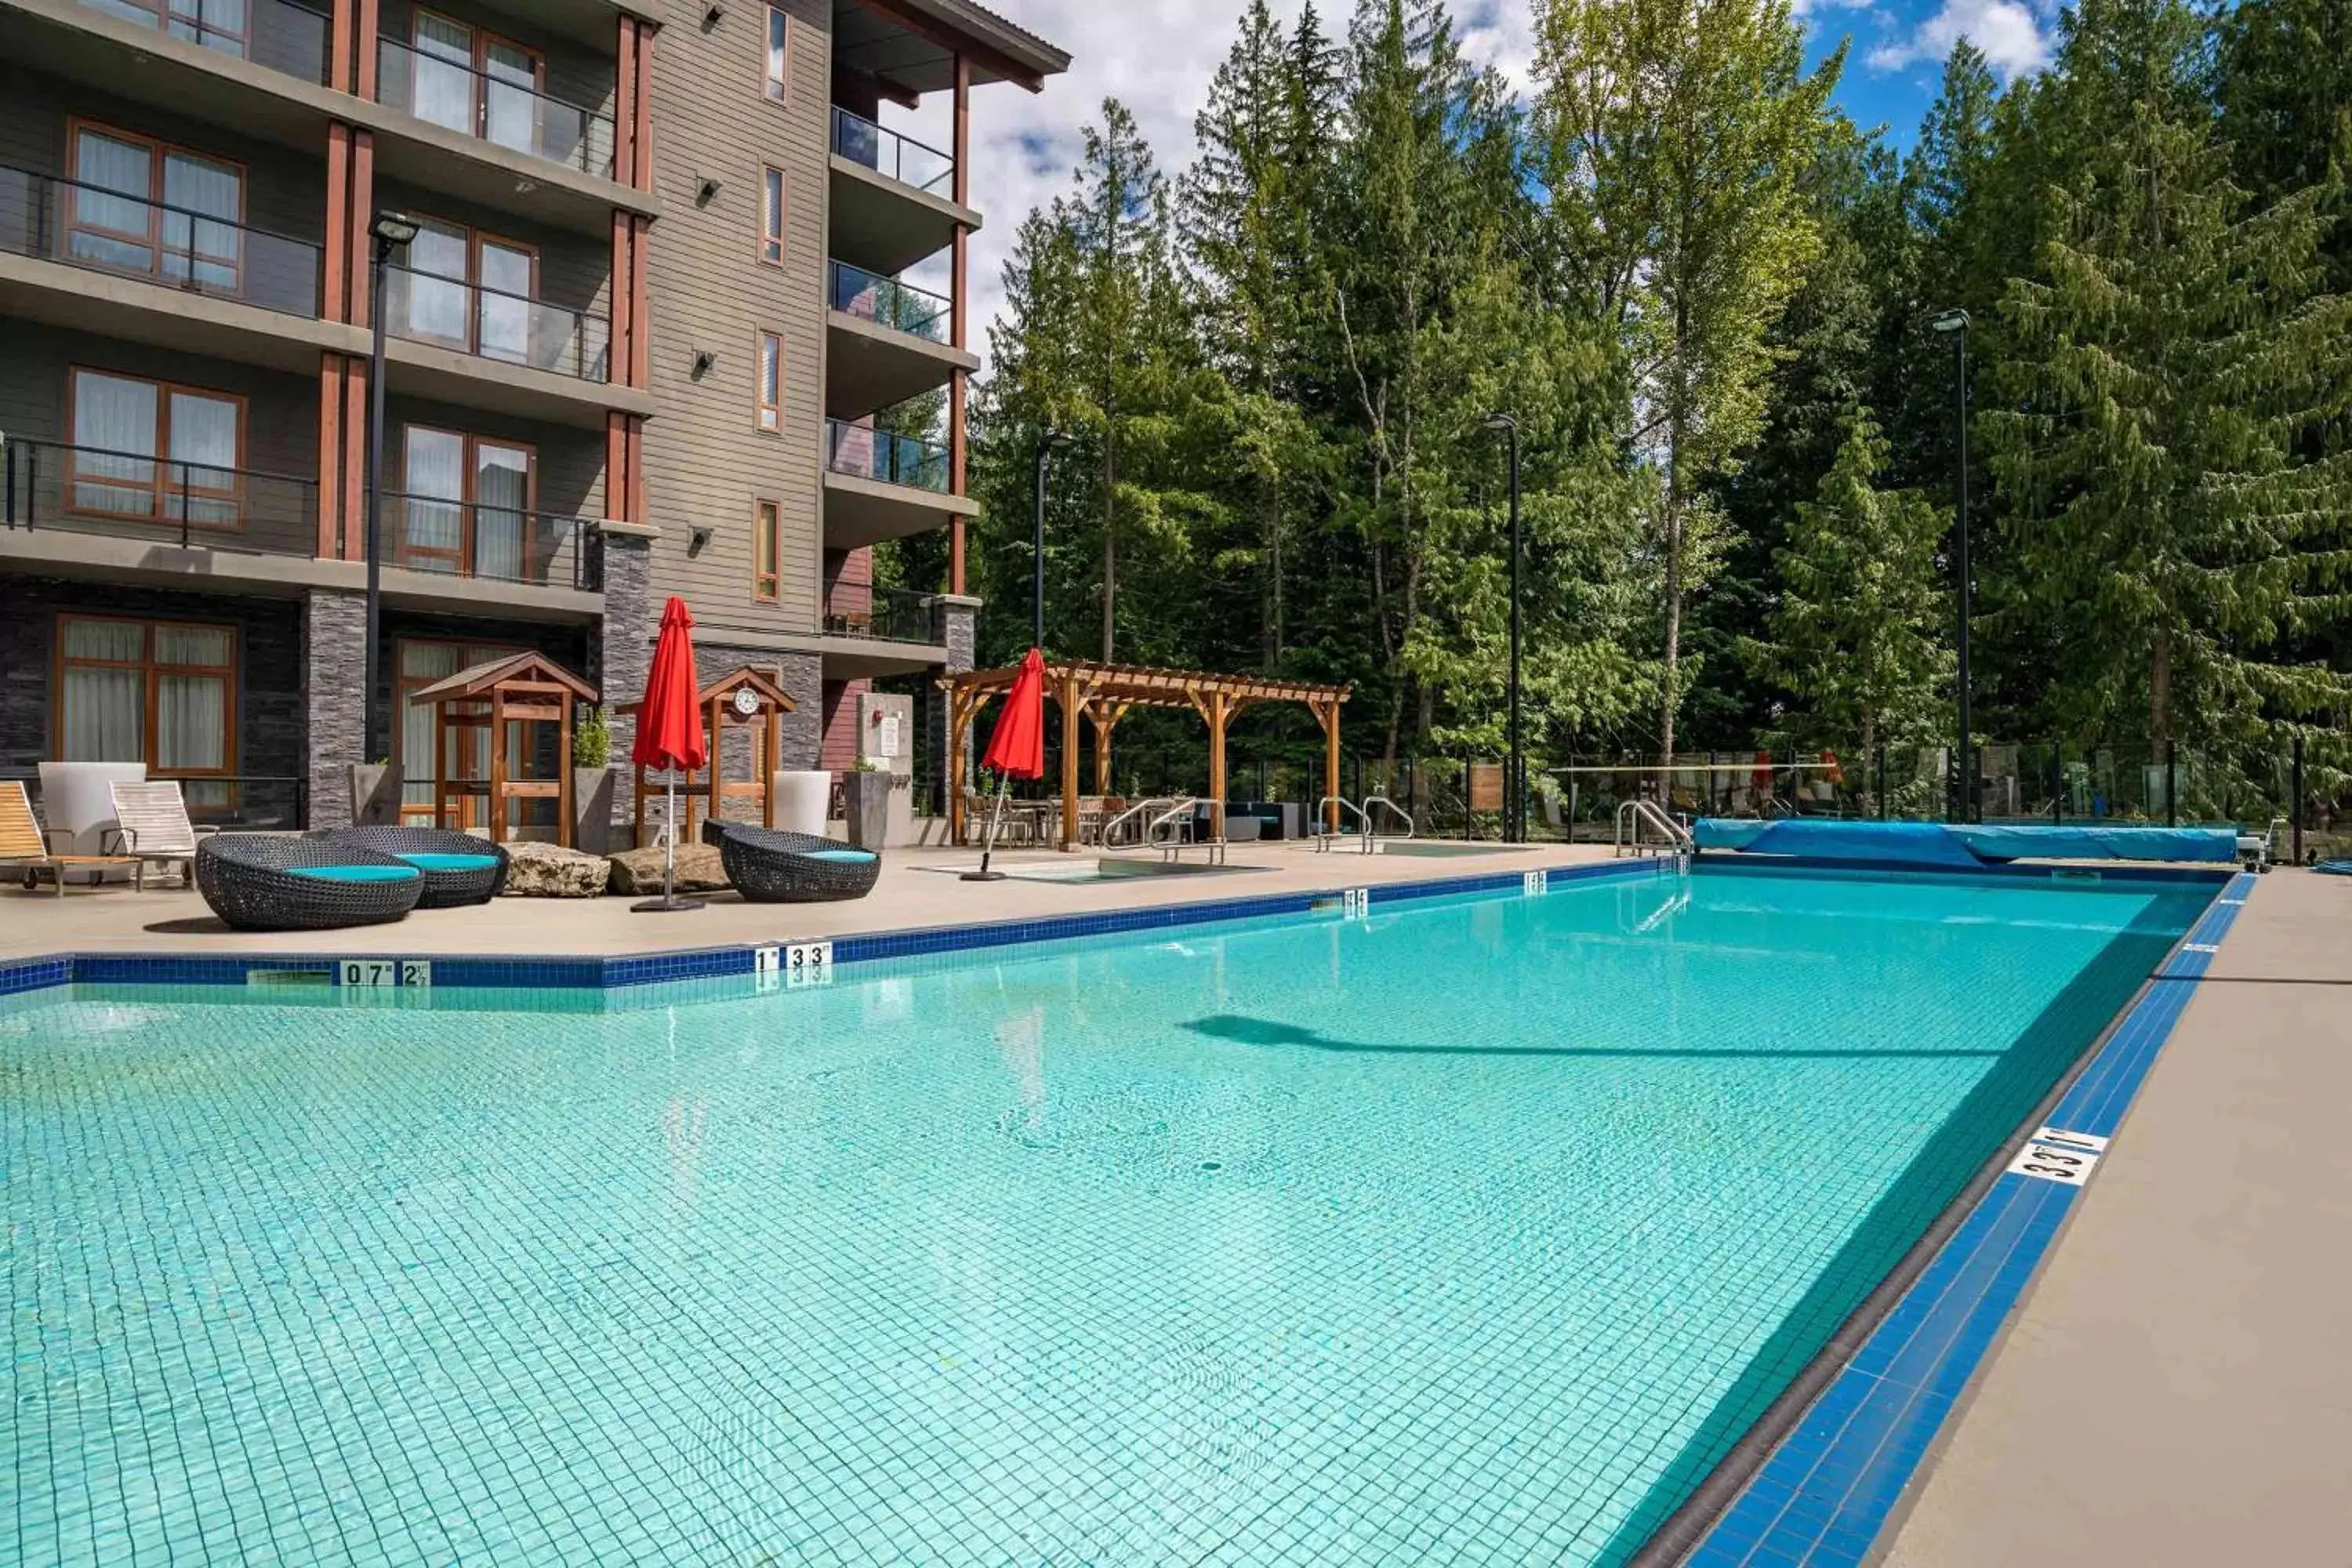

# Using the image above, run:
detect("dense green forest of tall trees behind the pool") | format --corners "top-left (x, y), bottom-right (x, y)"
top-left (877, 0), bottom-right (2352, 827)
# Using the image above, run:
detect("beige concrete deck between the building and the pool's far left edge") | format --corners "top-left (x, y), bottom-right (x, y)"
top-left (0, 841), bottom-right (1611, 959)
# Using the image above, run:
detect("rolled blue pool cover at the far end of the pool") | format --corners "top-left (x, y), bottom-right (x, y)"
top-left (1691, 815), bottom-right (2237, 869)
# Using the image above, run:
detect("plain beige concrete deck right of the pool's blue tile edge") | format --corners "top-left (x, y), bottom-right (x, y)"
top-left (1879, 869), bottom-right (2352, 1568)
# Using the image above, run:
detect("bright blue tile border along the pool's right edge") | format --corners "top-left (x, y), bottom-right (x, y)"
top-left (1679, 872), bottom-right (2253, 1568)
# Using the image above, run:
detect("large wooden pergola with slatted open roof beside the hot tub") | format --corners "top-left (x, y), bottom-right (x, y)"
top-left (938, 661), bottom-right (1350, 848)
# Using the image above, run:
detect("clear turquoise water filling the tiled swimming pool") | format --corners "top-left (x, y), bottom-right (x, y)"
top-left (0, 872), bottom-right (2211, 1566)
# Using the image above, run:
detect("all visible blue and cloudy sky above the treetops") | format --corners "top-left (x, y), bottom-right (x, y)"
top-left (884, 0), bottom-right (2056, 353)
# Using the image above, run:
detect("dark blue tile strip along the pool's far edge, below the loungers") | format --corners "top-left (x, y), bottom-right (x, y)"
top-left (0, 858), bottom-right (1675, 996)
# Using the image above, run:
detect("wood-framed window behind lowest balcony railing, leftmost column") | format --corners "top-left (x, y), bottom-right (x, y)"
top-left (66, 369), bottom-right (245, 529)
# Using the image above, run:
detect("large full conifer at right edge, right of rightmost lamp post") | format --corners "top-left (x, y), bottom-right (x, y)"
top-left (1983, 0), bottom-right (2352, 746)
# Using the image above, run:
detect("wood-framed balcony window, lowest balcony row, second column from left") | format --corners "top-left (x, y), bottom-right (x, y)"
top-left (400, 426), bottom-right (539, 583)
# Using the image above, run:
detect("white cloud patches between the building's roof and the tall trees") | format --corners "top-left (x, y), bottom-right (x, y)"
top-left (884, 0), bottom-right (1536, 376)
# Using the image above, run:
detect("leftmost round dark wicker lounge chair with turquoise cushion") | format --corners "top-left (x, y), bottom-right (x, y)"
top-left (195, 832), bottom-right (426, 931)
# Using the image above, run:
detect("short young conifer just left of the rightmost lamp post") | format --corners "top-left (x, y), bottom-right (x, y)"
top-left (1750, 409), bottom-right (1952, 767)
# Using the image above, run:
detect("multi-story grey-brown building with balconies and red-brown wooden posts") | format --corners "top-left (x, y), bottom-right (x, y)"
top-left (0, 0), bottom-right (1068, 825)
